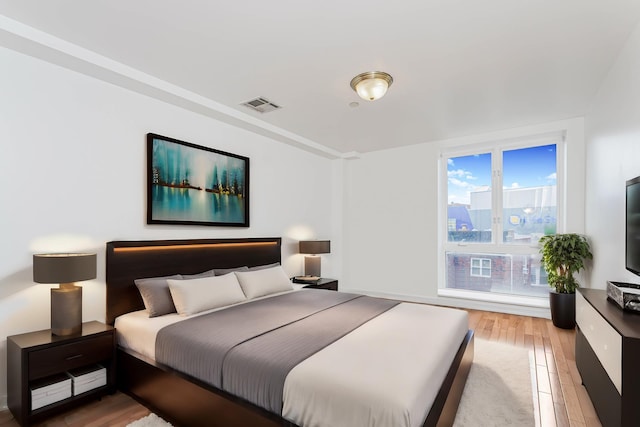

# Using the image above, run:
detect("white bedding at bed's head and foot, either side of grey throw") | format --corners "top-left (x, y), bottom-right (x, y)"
top-left (115, 294), bottom-right (468, 427)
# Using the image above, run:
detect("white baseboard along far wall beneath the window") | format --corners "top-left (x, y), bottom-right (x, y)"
top-left (340, 289), bottom-right (551, 319)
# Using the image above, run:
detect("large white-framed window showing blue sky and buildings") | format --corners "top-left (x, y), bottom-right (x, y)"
top-left (440, 135), bottom-right (562, 297)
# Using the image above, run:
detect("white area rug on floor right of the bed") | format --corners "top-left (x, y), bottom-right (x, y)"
top-left (454, 338), bottom-right (535, 427)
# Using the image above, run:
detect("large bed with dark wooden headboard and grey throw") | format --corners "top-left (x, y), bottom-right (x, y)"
top-left (106, 238), bottom-right (473, 427)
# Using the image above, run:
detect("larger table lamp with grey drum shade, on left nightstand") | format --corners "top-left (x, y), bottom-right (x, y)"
top-left (33, 254), bottom-right (96, 335)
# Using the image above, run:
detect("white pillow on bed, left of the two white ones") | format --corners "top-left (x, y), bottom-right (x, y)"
top-left (167, 273), bottom-right (246, 316)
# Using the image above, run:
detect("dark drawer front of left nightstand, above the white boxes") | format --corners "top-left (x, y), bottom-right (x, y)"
top-left (29, 334), bottom-right (113, 380)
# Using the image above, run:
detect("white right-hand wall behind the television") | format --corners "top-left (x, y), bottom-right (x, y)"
top-left (586, 19), bottom-right (640, 289)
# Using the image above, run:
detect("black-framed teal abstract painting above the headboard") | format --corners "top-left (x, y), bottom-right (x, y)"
top-left (147, 133), bottom-right (249, 227)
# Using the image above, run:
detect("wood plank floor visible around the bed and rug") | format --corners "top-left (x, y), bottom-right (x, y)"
top-left (0, 310), bottom-right (600, 427)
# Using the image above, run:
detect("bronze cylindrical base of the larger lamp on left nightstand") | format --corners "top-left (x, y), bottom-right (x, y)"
top-left (51, 283), bottom-right (82, 336)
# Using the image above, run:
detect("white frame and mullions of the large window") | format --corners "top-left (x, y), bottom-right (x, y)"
top-left (438, 131), bottom-right (566, 305)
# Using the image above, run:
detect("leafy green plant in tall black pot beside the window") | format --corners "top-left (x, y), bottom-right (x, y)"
top-left (540, 233), bottom-right (593, 329)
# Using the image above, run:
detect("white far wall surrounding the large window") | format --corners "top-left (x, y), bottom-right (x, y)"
top-left (340, 118), bottom-right (585, 315)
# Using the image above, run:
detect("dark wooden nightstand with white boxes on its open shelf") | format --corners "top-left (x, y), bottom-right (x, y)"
top-left (7, 321), bottom-right (116, 426)
